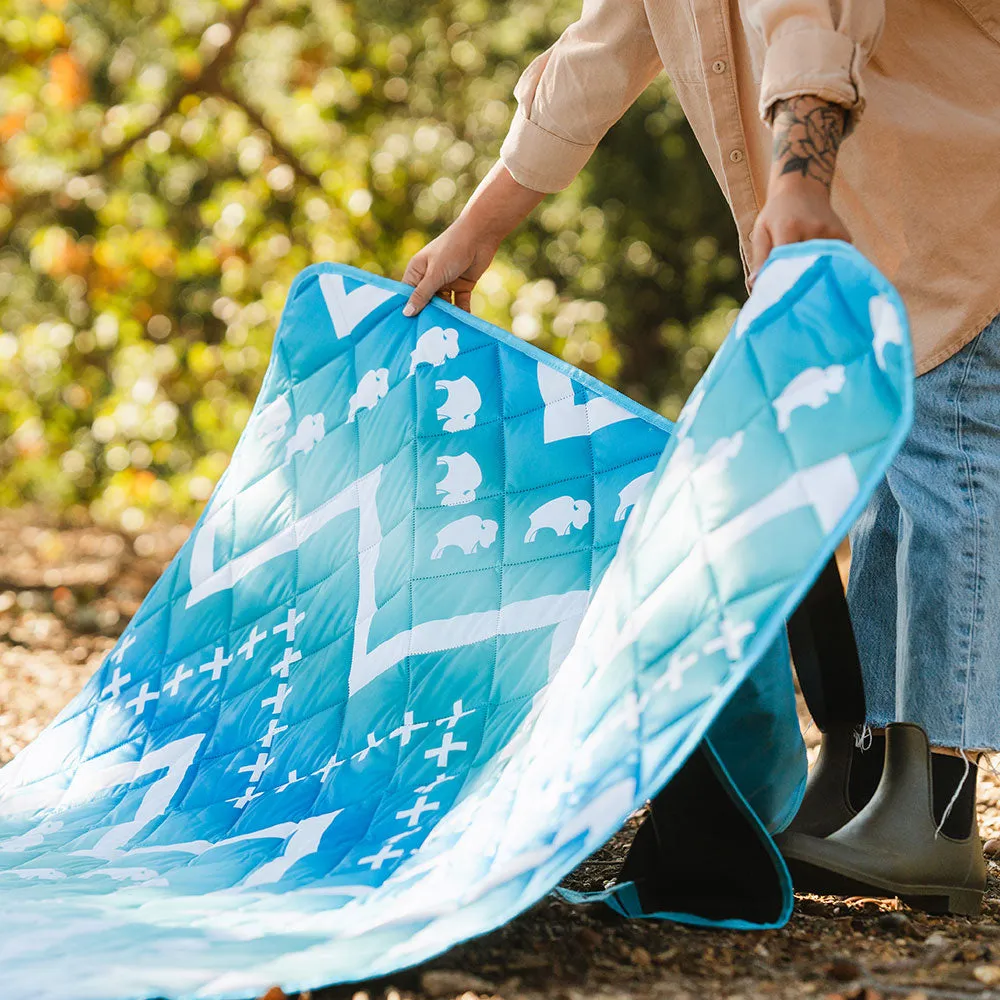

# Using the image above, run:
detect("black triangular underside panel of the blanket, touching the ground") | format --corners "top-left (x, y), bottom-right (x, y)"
top-left (619, 743), bottom-right (784, 923)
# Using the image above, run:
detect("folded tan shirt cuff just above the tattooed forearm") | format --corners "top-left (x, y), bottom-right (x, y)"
top-left (759, 28), bottom-right (865, 131)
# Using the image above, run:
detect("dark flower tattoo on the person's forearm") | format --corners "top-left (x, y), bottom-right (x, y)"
top-left (771, 97), bottom-right (847, 187)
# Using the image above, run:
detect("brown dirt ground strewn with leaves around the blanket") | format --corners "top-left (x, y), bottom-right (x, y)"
top-left (0, 512), bottom-right (1000, 1000)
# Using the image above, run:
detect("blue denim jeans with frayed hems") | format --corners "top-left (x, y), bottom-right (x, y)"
top-left (847, 316), bottom-right (1000, 750)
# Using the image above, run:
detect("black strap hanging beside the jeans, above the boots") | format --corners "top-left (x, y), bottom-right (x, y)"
top-left (788, 557), bottom-right (865, 733)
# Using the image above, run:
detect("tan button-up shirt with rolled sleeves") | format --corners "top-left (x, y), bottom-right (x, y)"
top-left (500, 0), bottom-right (1000, 373)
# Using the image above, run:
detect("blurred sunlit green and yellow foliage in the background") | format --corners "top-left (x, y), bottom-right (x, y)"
top-left (0, 0), bottom-right (743, 531)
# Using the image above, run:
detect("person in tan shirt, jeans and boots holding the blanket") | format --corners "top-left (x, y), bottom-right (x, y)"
top-left (404, 0), bottom-right (1000, 913)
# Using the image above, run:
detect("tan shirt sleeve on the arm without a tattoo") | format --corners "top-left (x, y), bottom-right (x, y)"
top-left (500, 0), bottom-right (663, 193)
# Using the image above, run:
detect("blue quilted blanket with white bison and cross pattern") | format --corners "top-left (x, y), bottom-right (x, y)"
top-left (0, 243), bottom-right (913, 1000)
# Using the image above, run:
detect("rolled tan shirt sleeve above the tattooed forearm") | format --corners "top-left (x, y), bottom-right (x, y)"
top-left (741, 0), bottom-right (885, 128)
